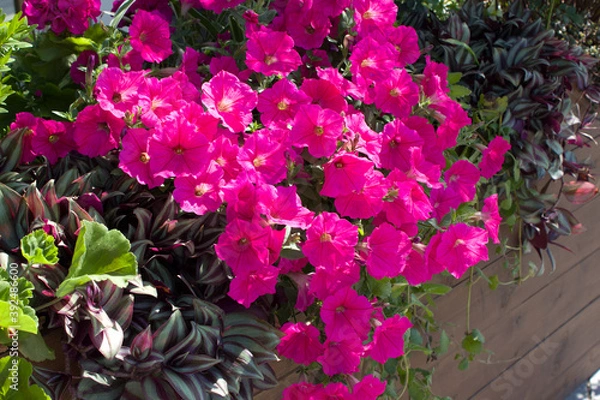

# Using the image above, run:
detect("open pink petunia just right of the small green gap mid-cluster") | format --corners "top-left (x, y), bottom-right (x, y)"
top-left (302, 212), bottom-right (358, 267)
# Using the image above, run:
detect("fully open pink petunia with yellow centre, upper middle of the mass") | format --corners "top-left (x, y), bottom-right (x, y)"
top-left (291, 104), bottom-right (344, 158)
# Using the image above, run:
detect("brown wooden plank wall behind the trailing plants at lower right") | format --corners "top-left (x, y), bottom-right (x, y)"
top-left (255, 110), bottom-right (600, 400)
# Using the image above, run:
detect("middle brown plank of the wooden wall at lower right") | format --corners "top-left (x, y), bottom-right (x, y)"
top-left (434, 250), bottom-right (600, 399)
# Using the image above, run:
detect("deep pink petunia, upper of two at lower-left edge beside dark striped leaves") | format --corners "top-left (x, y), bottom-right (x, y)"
top-left (215, 218), bottom-right (271, 275)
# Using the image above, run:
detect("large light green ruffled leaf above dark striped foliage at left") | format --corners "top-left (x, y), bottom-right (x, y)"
top-left (56, 221), bottom-right (137, 297)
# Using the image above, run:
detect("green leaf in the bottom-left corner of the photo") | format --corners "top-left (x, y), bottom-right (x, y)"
top-left (0, 356), bottom-right (51, 400)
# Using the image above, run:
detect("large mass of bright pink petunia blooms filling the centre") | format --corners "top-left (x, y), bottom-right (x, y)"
top-left (18, 0), bottom-right (509, 399)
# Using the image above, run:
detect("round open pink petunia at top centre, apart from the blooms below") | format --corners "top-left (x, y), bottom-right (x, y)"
top-left (246, 28), bottom-right (301, 76)
